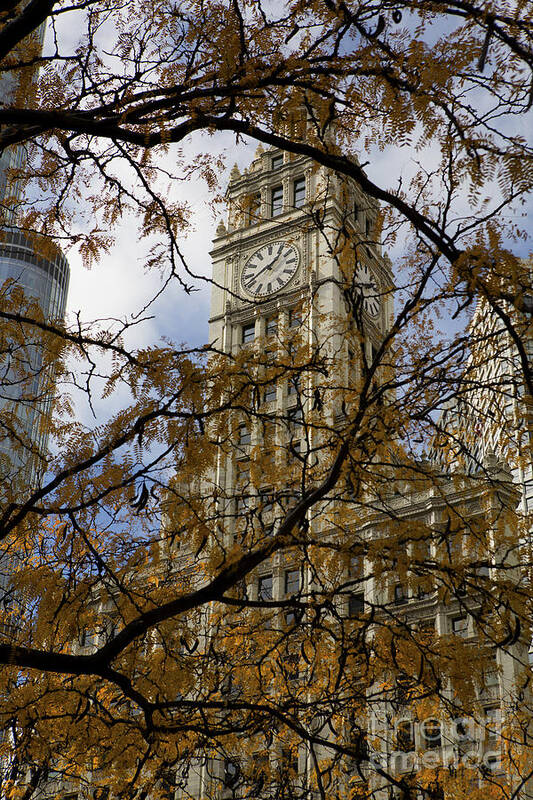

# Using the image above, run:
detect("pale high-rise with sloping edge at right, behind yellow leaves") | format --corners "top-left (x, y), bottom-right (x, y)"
top-left (431, 278), bottom-right (533, 515)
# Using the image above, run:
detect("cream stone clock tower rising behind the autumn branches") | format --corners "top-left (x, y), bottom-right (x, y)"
top-left (209, 145), bottom-right (393, 502)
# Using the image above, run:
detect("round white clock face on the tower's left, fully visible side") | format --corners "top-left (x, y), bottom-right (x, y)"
top-left (241, 242), bottom-right (300, 297)
